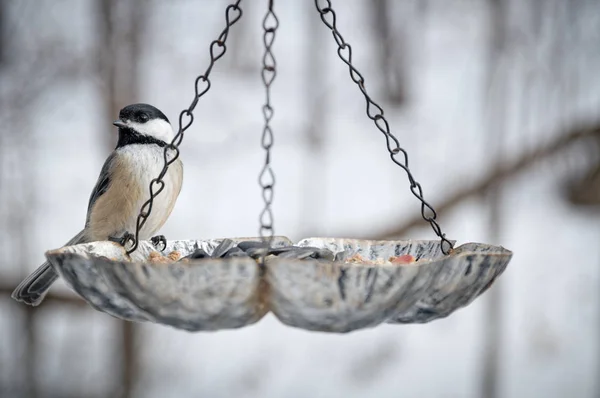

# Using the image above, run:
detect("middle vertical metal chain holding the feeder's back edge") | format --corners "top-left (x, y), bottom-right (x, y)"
top-left (258, 0), bottom-right (279, 249)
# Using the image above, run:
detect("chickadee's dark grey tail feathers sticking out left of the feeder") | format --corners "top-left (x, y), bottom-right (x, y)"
top-left (12, 231), bottom-right (84, 307)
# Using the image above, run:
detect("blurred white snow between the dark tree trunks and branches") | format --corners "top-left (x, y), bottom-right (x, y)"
top-left (0, 0), bottom-right (600, 398)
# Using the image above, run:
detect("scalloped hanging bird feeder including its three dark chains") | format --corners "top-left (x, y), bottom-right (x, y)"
top-left (46, 0), bottom-right (512, 333)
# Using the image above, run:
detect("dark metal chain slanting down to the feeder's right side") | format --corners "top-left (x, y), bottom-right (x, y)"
top-left (315, 0), bottom-right (453, 254)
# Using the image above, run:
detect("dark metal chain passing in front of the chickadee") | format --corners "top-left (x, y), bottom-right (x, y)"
top-left (127, 0), bottom-right (242, 254)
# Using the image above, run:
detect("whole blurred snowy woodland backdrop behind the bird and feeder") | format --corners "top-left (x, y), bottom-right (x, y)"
top-left (0, 0), bottom-right (600, 398)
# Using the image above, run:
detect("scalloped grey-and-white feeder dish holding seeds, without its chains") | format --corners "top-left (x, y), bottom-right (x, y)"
top-left (46, 237), bottom-right (512, 333)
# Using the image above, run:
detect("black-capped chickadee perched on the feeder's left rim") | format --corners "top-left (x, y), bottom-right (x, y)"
top-left (12, 104), bottom-right (183, 306)
